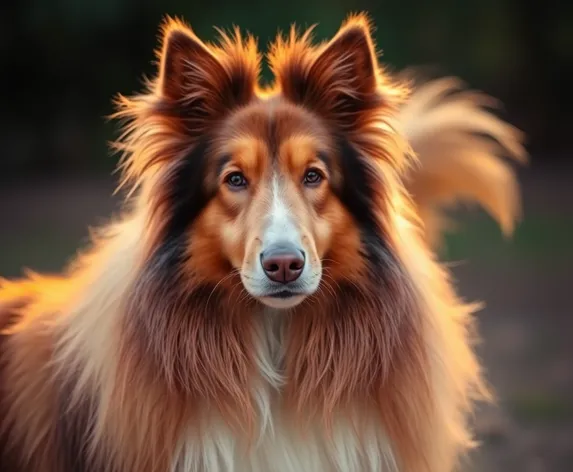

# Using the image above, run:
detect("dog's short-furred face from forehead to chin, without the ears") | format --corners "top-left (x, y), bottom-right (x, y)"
top-left (207, 103), bottom-right (336, 308)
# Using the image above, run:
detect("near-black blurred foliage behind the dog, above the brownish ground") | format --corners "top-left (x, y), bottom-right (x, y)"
top-left (0, 0), bottom-right (573, 178)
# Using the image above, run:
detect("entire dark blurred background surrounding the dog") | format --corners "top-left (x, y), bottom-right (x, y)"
top-left (0, 0), bottom-right (573, 472)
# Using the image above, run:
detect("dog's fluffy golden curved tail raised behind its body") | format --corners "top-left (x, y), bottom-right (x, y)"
top-left (400, 78), bottom-right (527, 245)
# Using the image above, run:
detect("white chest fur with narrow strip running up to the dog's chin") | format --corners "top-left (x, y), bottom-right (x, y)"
top-left (172, 312), bottom-right (397, 472)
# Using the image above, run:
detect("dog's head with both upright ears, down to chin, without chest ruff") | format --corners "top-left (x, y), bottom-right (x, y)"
top-left (123, 19), bottom-right (404, 308)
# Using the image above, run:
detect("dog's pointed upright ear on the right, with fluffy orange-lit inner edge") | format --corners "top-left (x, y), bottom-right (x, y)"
top-left (270, 16), bottom-right (398, 128)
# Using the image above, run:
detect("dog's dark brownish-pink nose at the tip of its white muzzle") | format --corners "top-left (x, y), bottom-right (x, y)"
top-left (261, 244), bottom-right (304, 284)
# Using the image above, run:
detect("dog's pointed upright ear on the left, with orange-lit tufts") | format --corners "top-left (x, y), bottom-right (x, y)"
top-left (158, 19), bottom-right (259, 119)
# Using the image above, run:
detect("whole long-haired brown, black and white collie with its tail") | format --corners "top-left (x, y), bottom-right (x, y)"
top-left (0, 12), bottom-right (525, 472)
